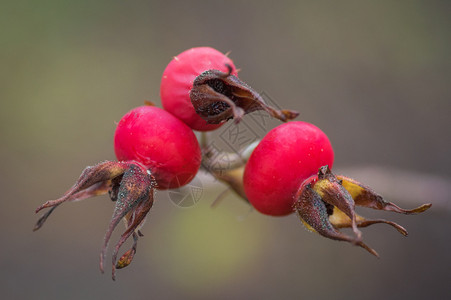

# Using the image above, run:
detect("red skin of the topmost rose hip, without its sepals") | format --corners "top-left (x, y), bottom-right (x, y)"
top-left (160, 47), bottom-right (237, 131)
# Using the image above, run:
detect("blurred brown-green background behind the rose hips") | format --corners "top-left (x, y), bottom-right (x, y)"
top-left (0, 0), bottom-right (451, 299)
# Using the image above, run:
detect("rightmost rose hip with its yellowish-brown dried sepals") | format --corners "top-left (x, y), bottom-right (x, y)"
top-left (243, 122), bottom-right (431, 256)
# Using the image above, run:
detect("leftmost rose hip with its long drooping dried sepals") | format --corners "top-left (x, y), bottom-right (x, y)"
top-left (34, 106), bottom-right (201, 279)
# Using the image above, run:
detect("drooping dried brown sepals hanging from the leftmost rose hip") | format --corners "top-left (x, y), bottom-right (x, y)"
top-left (33, 161), bottom-right (156, 280)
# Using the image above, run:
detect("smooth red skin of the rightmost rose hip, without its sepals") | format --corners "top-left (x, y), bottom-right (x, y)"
top-left (243, 121), bottom-right (334, 216)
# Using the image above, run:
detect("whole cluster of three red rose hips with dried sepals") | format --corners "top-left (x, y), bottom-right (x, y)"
top-left (35, 47), bottom-right (430, 279)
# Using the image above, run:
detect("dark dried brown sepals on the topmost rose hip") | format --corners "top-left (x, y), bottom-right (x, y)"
top-left (190, 65), bottom-right (299, 124)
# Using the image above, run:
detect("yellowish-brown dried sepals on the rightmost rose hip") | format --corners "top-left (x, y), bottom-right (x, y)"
top-left (294, 166), bottom-right (431, 256)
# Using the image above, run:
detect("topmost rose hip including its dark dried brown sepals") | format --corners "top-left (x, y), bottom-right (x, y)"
top-left (160, 47), bottom-right (298, 131)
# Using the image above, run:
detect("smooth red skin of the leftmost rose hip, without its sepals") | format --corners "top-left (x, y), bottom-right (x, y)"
top-left (114, 106), bottom-right (201, 189)
